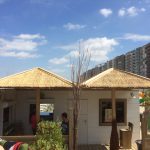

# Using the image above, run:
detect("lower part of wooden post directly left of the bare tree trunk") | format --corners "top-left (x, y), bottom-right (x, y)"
top-left (69, 108), bottom-right (73, 150)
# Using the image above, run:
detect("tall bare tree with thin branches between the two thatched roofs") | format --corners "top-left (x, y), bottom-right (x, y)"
top-left (71, 47), bottom-right (91, 150)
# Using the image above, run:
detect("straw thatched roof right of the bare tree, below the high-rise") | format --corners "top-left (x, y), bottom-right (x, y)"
top-left (83, 68), bottom-right (150, 89)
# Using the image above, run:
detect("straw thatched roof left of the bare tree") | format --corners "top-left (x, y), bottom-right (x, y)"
top-left (0, 68), bottom-right (72, 88)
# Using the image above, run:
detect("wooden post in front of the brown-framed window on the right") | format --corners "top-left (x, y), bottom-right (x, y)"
top-left (111, 89), bottom-right (116, 120)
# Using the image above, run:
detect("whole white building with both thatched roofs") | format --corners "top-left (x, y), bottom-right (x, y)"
top-left (0, 68), bottom-right (150, 145)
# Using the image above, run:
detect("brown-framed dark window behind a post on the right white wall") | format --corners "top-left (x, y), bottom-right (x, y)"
top-left (99, 99), bottom-right (127, 125)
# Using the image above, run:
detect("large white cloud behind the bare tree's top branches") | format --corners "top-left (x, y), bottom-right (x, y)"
top-left (48, 37), bottom-right (119, 78)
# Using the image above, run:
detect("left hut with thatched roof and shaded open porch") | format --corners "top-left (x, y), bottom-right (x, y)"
top-left (0, 68), bottom-right (72, 135)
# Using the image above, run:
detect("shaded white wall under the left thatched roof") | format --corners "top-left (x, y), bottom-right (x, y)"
top-left (16, 90), bottom-right (71, 134)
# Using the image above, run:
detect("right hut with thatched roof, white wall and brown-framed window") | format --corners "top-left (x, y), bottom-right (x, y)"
top-left (79, 68), bottom-right (150, 144)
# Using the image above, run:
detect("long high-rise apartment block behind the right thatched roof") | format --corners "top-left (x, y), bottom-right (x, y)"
top-left (82, 43), bottom-right (150, 79)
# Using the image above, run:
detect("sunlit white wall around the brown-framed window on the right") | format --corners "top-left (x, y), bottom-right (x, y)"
top-left (79, 91), bottom-right (140, 144)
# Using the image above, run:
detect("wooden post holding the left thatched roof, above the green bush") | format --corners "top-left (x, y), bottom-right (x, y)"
top-left (36, 88), bottom-right (40, 123)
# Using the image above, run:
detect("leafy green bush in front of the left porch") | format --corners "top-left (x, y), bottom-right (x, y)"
top-left (30, 121), bottom-right (66, 150)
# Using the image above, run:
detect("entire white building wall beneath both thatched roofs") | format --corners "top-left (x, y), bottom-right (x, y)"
top-left (0, 90), bottom-right (140, 144)
